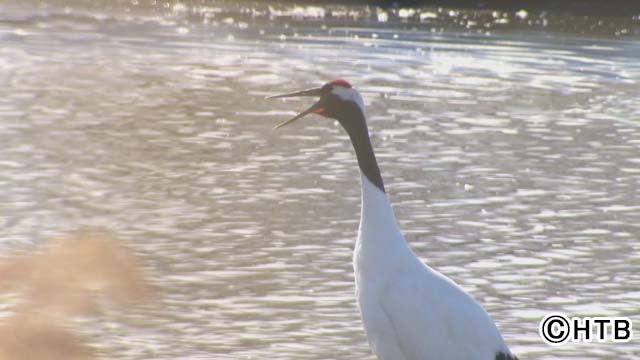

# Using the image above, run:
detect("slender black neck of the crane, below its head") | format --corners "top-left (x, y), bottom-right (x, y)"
top-left (338, 107), bottom-right (385, 192)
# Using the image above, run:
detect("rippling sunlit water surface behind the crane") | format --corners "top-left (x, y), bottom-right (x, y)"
top-left (0, 3), bottom-right (640, 359)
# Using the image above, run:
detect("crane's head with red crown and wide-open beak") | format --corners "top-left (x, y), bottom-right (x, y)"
top-left (267, 79), bottom-right (364, 129)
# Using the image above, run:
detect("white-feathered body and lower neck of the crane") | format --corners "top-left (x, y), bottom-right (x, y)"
top-left (353, 176), bottom-right (510, 360)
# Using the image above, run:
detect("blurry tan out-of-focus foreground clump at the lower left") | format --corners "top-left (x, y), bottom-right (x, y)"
top-left (0, 232), bottom-right (150, 360)
